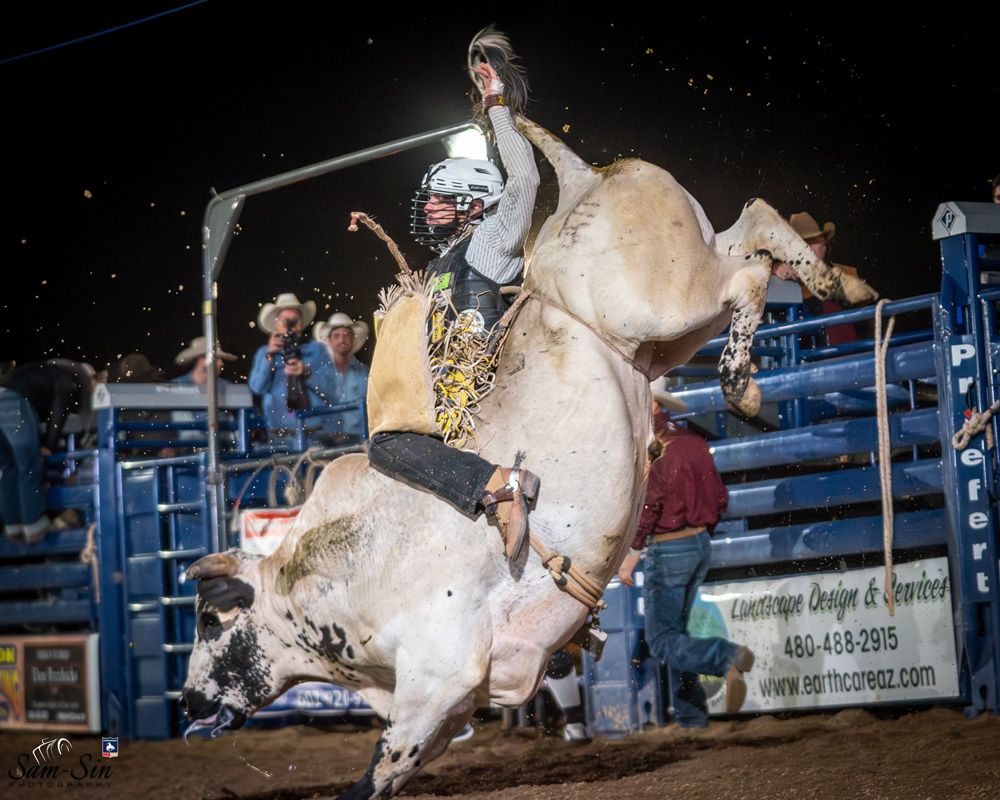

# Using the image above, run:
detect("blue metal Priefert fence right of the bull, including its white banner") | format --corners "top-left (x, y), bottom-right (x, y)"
top-left (585, 203), bottom-right (1000, 735)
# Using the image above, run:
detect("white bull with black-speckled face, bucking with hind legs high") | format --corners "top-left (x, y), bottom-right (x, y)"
top-left (184, 115), bottom-right (873, 798)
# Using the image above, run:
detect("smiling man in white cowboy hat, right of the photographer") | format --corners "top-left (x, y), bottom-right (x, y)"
top-left (313, 311), bottom-right (368, 443)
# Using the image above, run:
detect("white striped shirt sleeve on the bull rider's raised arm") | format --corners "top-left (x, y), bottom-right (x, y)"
top-left (465, 106), bottom-right (539, 283)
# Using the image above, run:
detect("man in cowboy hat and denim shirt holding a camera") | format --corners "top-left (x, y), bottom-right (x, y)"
top-left (248, 293), bottom-right (333, 445)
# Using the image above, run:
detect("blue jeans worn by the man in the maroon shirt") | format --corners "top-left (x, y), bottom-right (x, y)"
top-left (643, 532), bottom-right (738, 728)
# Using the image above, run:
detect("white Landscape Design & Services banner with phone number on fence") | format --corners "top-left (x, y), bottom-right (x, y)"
top-left (688, 558), bottom-right (959, 713)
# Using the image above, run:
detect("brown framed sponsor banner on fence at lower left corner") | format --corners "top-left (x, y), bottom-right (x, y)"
top-left (0, 633), bottom-right (101, 731)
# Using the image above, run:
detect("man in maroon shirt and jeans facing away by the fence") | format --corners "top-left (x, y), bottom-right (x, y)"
top-left (618, 400), bottom-right (754, 728)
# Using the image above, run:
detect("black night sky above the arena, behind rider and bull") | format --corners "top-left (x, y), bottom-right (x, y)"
top-left (0, 5), bottom-right (1000, 377)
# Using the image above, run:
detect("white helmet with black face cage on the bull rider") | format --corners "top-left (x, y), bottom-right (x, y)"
top-left (410, 158), bottom-right (503, 247)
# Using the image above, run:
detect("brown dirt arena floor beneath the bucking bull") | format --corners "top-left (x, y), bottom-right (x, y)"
top-left (0, 708), bottom-right (1000, 800)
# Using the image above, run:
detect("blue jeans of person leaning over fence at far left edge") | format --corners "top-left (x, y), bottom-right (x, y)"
top-left (0, 388), bottom-right (45, 525)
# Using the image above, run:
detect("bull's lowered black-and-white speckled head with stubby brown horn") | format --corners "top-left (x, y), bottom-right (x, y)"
top-left (181, 549), bottom-right (283, 736)
